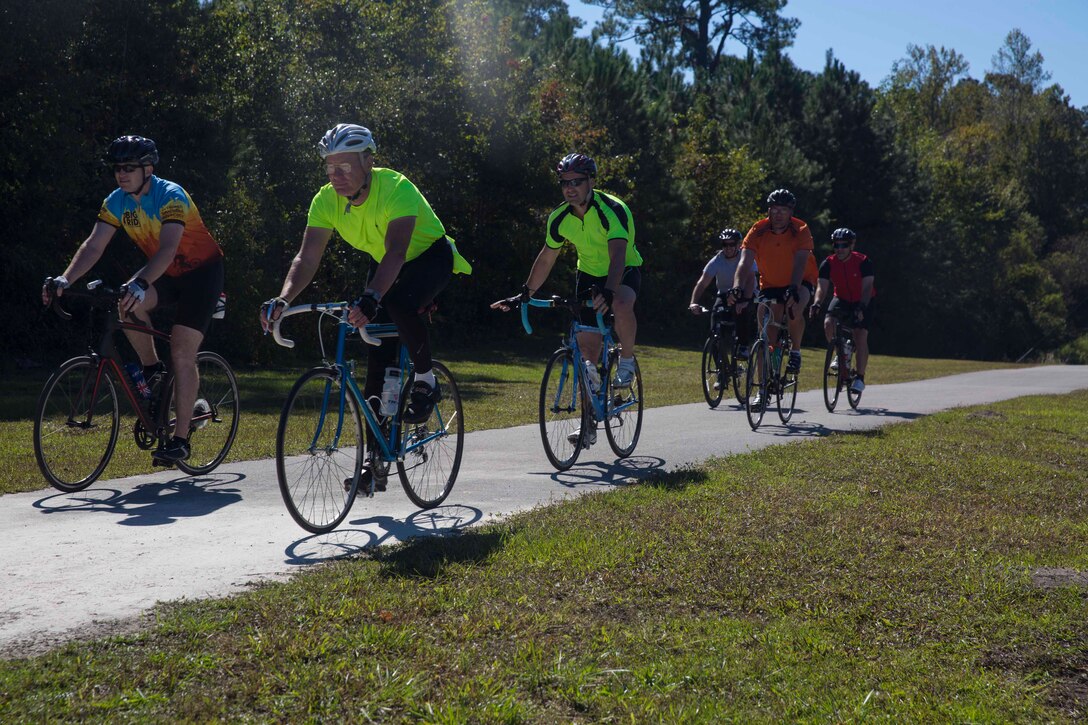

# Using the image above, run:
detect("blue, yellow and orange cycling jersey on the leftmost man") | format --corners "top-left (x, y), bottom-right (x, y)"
top-left (98, 175), bottom-right (223, 277)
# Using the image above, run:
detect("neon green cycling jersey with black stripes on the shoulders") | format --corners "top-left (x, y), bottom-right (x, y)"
top-left (544, 189), bottom-right (642, 277)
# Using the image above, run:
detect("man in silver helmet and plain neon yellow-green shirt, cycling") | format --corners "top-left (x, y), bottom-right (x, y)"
top-left (260, 123), bottom-right (472, 483)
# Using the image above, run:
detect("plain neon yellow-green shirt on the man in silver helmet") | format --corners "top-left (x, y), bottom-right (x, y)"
top-left (306, 167), bottom-right (472, 274)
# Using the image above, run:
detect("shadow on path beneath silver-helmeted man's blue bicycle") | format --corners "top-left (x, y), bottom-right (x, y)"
top-left (285, 504), bottom-right (483, 566)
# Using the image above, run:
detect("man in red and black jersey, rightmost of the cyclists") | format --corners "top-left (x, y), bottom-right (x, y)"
top-left (809, 226), bottom-right (877, 393)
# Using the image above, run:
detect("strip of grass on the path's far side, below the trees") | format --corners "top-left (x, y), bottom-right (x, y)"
top-left (0, 335), bottom-right (1014, 494)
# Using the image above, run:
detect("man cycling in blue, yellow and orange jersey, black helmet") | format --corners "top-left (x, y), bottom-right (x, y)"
top-left (41, 136), bottom-right (223, 465)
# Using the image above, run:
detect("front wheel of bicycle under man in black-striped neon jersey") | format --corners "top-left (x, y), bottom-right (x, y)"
top-left (540, 347), bottom-right (595, 470)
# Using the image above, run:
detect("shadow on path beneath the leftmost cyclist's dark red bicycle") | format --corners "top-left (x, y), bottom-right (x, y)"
top-left (34, 472), bottom-right (246, 526)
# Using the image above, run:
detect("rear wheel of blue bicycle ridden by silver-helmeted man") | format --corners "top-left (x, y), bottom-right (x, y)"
top-left (397, 361), bottom-right (465, 508)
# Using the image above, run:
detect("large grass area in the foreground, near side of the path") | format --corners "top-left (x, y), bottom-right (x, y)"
top-left (0, 391), bottom-right (1088, 723)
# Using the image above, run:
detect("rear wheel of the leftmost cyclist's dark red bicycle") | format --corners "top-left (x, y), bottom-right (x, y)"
top-left (174, 351), bottom-right (239, 476)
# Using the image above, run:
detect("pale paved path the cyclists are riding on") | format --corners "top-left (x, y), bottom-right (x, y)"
top-left (0, 366), bottom-right (1088, 653)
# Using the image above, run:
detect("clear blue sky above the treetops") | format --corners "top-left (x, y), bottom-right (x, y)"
top-left (567, 0), bottom-right (1088, 107)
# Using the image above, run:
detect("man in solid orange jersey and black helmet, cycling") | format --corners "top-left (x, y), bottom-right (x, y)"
top-left (733, 188), bottom-right (817, 383)
